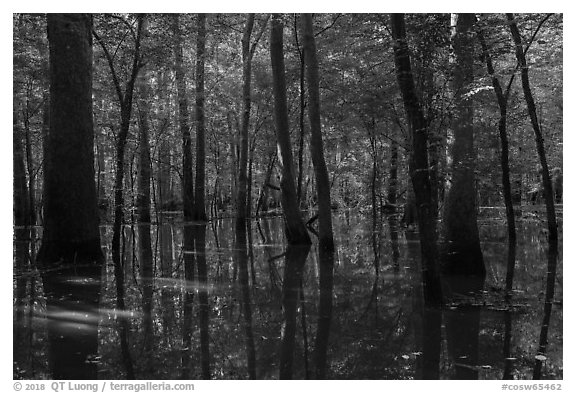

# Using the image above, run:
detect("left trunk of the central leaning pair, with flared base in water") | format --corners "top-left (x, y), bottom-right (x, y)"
top-left (270, 15), bottom-right (311, 245)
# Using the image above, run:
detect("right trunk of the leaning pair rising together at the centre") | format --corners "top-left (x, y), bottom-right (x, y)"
top-left (302, 14), bottom-right (334, 250)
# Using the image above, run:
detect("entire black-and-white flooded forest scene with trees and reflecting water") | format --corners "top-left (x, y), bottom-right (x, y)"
top-left (12, 13), bottom-right (563, 380)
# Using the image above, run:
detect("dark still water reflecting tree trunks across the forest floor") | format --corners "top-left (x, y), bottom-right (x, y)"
top-left (13, 213), bottom-right (563, 379)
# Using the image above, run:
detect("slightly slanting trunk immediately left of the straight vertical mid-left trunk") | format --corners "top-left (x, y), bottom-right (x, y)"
top-left (173, 14), bottom-right (194, 221)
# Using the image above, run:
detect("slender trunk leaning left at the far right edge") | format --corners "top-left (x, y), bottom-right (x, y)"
top-left (506, 14), bottom-right (558, 247)
